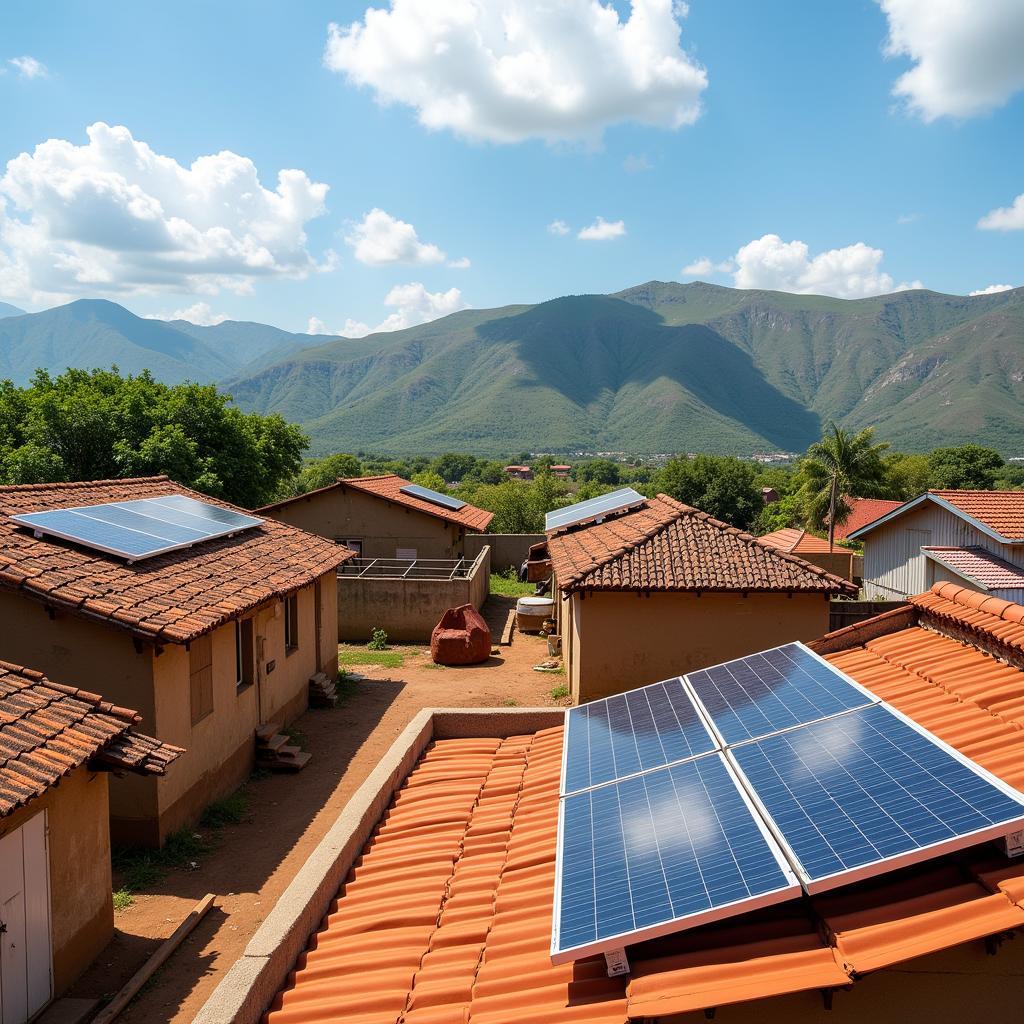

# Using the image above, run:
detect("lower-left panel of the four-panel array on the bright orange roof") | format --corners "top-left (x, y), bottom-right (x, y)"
top-left (551, 755), bottom-right (800, 964)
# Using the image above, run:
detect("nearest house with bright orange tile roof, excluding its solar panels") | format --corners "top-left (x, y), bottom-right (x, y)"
top-left (197, 584), bottom-right (1024, 1024)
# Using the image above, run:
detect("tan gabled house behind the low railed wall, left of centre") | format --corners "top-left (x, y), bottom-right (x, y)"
top-left (257, 473), bottom-right (494, 560)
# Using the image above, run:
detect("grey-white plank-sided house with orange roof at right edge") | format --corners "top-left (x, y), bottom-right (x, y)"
top-left (849, 490), bottom-right (1024, 603)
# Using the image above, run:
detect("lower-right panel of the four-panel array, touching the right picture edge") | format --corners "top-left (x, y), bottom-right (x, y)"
top-left (731, 705), bottom-right (1024, 892)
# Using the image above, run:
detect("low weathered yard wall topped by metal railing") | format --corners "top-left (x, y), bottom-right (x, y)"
top-left (338, 547), bottom-right (490, 643)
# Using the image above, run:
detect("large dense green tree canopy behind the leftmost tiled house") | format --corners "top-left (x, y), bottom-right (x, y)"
top-left (0, 368), bottom-right (309, 508)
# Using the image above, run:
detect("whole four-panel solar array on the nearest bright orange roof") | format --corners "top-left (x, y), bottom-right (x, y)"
top-left (551, 644), bottom-right (1024, 964)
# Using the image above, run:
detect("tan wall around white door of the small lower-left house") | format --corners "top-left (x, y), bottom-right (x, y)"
top-left (0, 768), bottom-right (114, 995)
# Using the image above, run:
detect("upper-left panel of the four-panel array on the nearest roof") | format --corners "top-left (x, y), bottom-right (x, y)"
top-left (562, 679), bottom-right (718, 793)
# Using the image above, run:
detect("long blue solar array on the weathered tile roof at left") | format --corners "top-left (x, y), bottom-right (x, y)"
top-left (10, 495), bottom-right (263, 561)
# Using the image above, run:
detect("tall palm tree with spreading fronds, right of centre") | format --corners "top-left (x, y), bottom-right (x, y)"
top-left (800, 423), bottom-right (889, 551)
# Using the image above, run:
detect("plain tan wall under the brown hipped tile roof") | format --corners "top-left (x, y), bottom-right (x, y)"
top-left (561, 592), bottom-right (829, 703)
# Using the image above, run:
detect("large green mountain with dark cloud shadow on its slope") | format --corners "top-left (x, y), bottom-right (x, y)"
top-left (225, 282), bottom-right (1024, 456)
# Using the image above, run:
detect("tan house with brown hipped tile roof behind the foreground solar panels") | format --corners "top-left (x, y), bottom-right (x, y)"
top-left (548, 495), bottom-right (857, 702)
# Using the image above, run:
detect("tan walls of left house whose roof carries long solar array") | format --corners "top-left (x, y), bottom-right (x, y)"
top-left (0, 572), bottom-right (338, 846)
